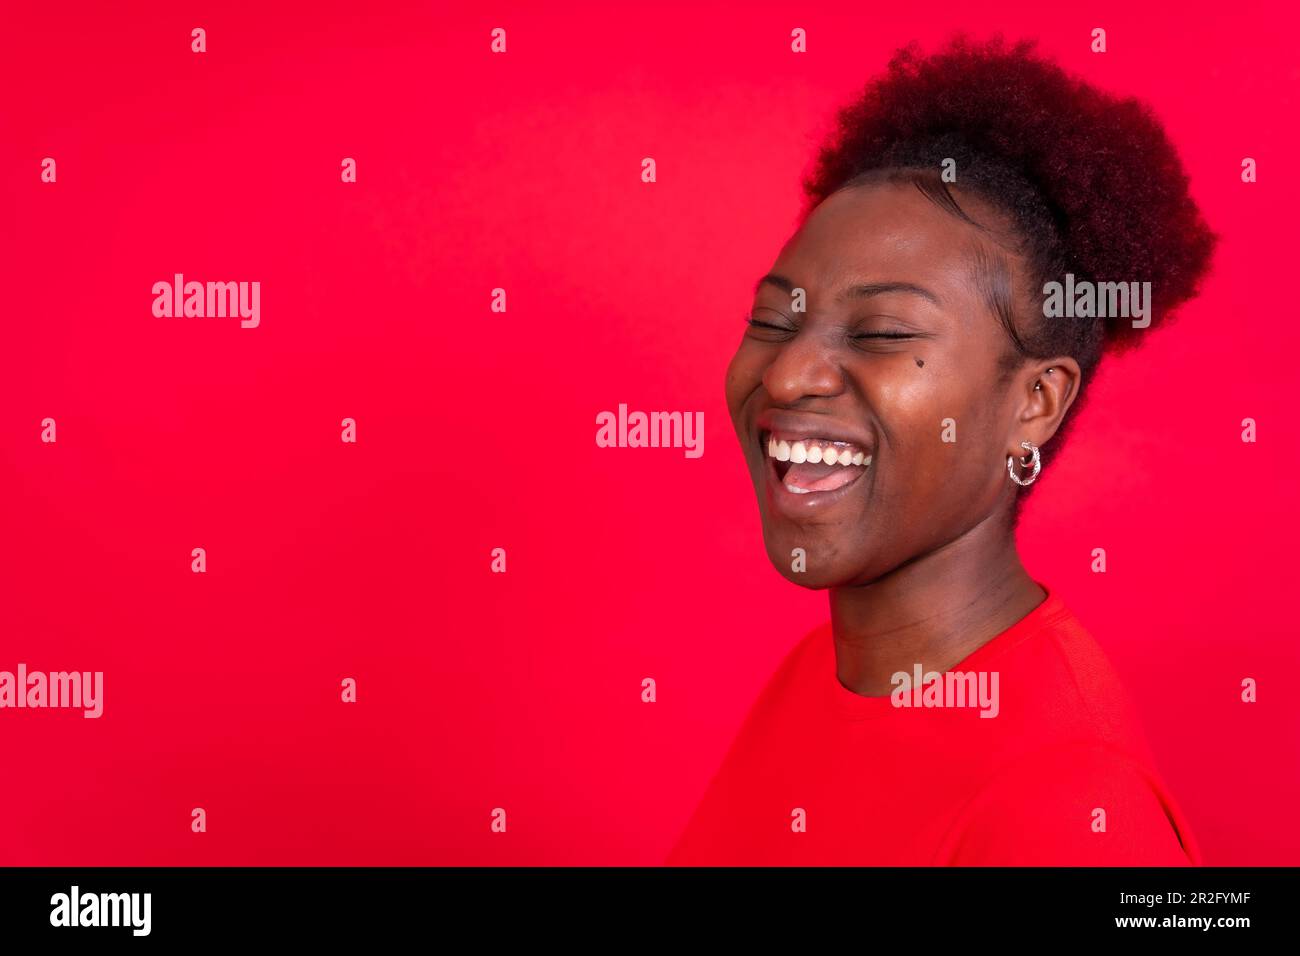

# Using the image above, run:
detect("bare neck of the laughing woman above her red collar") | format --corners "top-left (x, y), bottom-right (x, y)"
top-left (831, 515), bottom-right (1047, 697)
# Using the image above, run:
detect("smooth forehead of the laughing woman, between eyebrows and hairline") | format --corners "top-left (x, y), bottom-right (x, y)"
top-left (772, 182), bottom-right (984, 310)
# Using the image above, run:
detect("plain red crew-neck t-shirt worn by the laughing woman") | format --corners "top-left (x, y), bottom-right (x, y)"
top-left (667, 585), bottom-right (1201, 866)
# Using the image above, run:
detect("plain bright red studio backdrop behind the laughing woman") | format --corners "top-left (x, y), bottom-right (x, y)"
top-left (0, 3), bottom-right (1300, 865)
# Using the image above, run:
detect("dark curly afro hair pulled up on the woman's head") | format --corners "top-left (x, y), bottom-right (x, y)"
top-left (801, 36), bottom-right (1217, 497)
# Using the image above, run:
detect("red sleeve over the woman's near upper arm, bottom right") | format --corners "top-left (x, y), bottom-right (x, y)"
top-left (936, 743), bottom-right (1200, 866)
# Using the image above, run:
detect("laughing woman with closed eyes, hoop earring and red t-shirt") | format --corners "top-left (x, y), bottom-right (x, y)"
top-left (668, 40), bottom-right (1214, 865)
